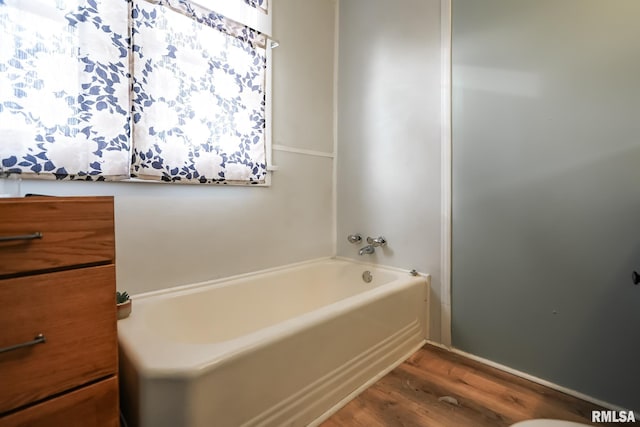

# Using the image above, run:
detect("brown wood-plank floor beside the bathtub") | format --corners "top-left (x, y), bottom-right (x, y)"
top-left (321, 344), bottom-right (603, 427)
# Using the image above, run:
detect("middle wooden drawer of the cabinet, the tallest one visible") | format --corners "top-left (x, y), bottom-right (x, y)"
top-left (0, 265), bottom-right (117, 414)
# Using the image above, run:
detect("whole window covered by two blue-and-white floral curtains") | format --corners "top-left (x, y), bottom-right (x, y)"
top-left (0, 0), bottom-right (267, 184)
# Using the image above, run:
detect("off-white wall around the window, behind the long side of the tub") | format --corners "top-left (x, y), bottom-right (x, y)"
top-left (22, 0), bottom-right (335, 294)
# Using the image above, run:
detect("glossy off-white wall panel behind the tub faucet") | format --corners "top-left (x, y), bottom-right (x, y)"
top-left (337, 0), bottom-right (441, 340)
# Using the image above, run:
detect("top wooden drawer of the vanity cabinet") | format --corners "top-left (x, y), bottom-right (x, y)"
top-left (0, 197), bottom-right (115, 277)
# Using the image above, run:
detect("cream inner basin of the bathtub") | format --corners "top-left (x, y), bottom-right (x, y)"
top-left (138, 260), bottom-right (398, 344)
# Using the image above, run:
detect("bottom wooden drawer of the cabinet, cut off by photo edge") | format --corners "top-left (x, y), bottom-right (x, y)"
top-left (0, 377), bottom-right (119, 427)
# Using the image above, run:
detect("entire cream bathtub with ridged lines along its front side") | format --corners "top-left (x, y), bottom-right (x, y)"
top-left (118, 259), bottom-right (429, 427)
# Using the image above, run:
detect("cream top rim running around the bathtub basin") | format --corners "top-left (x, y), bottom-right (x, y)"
top-left (118, 257), bottom-right (431, 379)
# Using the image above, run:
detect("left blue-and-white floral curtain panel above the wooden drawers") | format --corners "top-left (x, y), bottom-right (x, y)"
top-left (0, 0), bottom-right (130, 180)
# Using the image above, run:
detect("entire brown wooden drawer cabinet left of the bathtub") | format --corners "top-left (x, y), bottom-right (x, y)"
top-left (0, 197), bottom-right (119, 427)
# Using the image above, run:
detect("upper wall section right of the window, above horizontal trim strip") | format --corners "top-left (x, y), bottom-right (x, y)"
top-left (273, 0), bottom-right (337, 153)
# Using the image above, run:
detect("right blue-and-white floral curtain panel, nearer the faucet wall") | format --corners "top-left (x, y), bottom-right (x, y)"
top-left (132, 0), bottom-right (267, 184)
